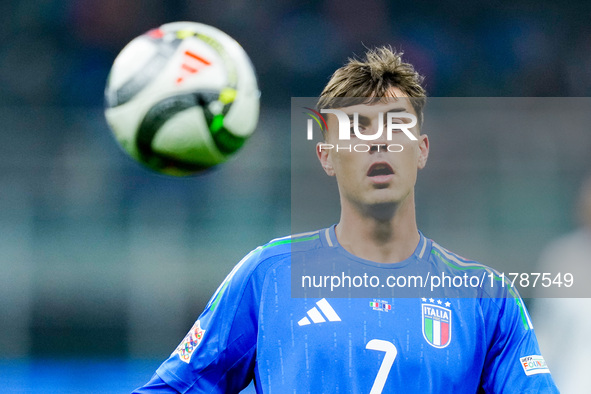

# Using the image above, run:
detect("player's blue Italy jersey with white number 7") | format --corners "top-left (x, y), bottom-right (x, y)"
top-left (137, 226), bottom-right (558, 394)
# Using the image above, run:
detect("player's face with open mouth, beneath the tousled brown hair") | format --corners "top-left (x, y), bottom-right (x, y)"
top-left (317, 88), bottom-right (429, 206)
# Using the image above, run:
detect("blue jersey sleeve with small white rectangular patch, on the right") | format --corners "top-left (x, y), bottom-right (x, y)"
top-left (481, 293), bottom-right (559, 393)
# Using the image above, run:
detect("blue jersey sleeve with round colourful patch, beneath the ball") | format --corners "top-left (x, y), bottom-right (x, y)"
top-left (136, 251), bottom-right (260, 393)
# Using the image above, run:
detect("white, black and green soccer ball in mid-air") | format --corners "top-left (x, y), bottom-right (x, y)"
top-left (105, 22), bottom-right (260, 176)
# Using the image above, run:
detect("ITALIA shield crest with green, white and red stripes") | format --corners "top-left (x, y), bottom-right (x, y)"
top-left (421, 298), bottom-right (452, 349)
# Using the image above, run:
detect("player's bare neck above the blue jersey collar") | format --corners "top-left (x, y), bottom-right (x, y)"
top-left (336, 199), bottom-right (420, 263)
